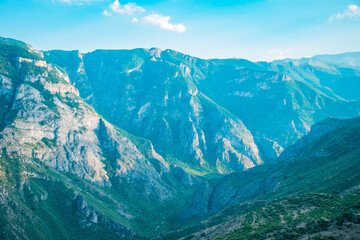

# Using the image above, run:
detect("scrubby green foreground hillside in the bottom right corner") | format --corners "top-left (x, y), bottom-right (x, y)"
top-left (218, 193), bottom-right (360, 239)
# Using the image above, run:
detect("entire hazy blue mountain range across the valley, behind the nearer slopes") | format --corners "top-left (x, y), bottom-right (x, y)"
top-left (44, 49), bottom-right (360, 169)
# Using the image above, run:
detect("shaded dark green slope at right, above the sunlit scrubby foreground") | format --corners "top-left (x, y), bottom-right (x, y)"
top-left (168, 118), bottom-right (360, 238)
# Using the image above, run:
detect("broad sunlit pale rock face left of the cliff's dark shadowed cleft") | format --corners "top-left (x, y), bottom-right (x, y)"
top-left (1, 79), bottom-right (110, 185)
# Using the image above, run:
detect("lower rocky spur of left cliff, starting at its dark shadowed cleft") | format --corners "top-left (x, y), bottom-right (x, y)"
top-left (97, 119), bottom-right (172, 201)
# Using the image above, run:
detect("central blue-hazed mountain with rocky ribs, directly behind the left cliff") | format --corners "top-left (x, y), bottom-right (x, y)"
top-left (45, 49), bottom-right (263, 173)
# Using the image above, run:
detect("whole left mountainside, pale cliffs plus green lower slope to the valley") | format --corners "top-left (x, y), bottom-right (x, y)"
top-left (0, 36), bottom-right (204, 239)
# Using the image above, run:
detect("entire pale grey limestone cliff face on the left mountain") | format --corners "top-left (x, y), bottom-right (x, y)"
top-left (0, 54), bottom-right (172, 201)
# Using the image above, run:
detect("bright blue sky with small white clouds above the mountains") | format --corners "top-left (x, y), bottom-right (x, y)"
top-left (0, 0), bottom-right (360, 61)
